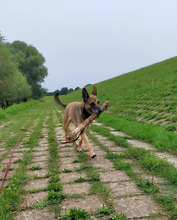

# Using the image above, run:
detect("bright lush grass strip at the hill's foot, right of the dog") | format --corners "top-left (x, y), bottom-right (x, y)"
top-left (97, 113), bottom-right (177, 155)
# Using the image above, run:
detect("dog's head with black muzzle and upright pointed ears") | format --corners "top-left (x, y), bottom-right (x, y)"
top-left (82, 86), bottom-right (102, 115)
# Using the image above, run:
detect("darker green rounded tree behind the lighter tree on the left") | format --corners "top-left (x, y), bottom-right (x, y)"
top-left (9, 41), bottom-right (48, 99)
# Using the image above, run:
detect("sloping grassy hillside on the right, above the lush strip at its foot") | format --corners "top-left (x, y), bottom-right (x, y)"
top-left (63, 57), bottom-right (177, 131)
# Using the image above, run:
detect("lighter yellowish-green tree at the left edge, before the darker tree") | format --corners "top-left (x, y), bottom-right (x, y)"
top-left (0, 35), bottom-right (31, 106)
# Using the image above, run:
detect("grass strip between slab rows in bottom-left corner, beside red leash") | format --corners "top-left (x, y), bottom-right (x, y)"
top-left (0, 115), bottom-right (43, 219)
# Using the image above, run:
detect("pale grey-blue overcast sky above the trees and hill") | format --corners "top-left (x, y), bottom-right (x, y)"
top-left (0, 0), bottom-right (177, 91)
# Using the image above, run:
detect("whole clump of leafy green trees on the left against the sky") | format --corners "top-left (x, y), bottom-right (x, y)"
top-left (0, 34), bottom-right (48, 108)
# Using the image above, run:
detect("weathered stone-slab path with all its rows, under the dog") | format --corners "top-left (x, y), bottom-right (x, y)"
top-left (0, 102), bottom-right (177, 220)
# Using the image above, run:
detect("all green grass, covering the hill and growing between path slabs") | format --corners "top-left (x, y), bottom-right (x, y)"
top-left (0, 57), bottom-right (177, 220)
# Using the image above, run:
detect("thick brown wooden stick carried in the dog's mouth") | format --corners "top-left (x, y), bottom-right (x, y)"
top-left (67, 101), bottom-right (109, 141)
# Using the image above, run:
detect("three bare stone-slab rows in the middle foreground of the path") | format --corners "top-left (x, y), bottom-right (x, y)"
top-left (10, 111), bottom-right (168, 220)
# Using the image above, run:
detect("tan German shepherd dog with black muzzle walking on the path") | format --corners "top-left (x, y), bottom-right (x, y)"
top-left (54, 86), bottom-right (102, 158)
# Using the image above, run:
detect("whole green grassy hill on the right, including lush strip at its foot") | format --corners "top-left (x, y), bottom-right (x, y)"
top-left (61, 57), bottom-right (177, 155)
